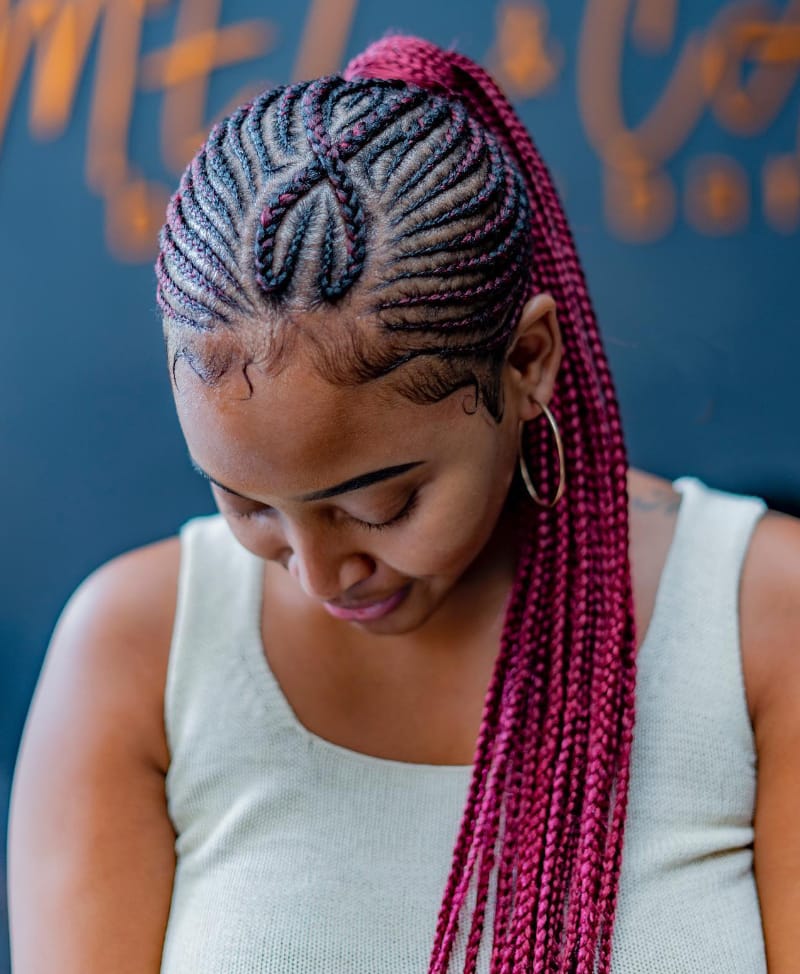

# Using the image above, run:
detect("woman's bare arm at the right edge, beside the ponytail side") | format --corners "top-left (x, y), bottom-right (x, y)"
top-left (741, 514), bottom-right (800, 974)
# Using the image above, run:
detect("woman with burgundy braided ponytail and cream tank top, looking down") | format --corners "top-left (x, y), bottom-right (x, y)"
top-left (10, 37), bottom-right (800, 974)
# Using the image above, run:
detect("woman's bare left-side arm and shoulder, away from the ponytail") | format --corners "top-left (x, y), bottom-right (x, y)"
top-left (9, 541), bottom-right (178, 974)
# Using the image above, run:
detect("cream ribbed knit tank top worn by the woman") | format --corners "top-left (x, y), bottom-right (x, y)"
top-left (161, 478), bottom-right (766, 974)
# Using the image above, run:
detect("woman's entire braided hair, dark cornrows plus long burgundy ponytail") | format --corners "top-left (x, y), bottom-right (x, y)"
top-left (156, 36), bottom-right (635, 974)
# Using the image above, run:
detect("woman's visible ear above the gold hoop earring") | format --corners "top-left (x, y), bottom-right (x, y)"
top-left (505, 294), bottom-right (563, 421)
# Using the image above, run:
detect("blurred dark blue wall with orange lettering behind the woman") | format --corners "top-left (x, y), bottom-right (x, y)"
top-left (0, 0), bottom-right (800, 974)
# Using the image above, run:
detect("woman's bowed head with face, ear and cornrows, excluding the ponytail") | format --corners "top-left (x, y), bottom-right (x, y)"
top-left (158, 42), bottom-right (558, 625)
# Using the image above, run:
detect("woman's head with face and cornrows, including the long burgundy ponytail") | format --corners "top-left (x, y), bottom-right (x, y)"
top-left (157, 37), bottom-right (634, 974)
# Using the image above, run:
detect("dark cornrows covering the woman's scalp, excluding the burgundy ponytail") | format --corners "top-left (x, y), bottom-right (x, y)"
top-left (157, 68), bottom-right (531, 416)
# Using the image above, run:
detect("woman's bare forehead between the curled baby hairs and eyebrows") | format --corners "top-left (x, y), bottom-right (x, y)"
top-left (174, 348), bottom-right (478, 496)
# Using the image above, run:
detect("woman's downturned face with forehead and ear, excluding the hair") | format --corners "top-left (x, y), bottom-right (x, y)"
top-left (175, 295), bottom-right (560, 634)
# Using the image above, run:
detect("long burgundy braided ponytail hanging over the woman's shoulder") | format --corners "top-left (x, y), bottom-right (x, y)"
top-left (345, 37), bottom-right (635, 974)
